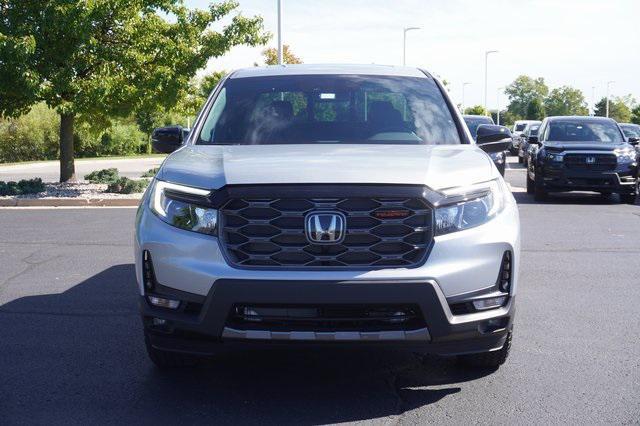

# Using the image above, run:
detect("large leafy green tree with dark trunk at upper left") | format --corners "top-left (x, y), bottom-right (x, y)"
top-left (0, 0), bottom-right (268, 181)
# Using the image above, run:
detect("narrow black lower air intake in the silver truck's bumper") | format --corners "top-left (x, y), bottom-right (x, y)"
top-left (227, 304), bottom-right (426, 332)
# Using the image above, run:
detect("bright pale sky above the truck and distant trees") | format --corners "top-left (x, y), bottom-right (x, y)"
top-left (186, 0), bottom-right (640, 108)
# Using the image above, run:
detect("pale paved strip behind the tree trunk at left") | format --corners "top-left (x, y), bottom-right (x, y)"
top-left (0, 156), bottom-right (164, 182)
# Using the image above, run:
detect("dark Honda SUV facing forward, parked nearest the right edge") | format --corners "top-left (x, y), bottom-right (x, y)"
top-left (527, 117), bottom-right (638, 204)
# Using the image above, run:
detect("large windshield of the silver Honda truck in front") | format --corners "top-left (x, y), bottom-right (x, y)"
top-left (196, 75), bottom-right (460, 145)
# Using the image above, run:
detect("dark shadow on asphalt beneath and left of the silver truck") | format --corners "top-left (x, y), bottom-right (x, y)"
top-left (0, 265), bottom-right (492, 424)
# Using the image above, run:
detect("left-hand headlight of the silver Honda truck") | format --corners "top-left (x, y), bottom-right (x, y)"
top-left (149, 179), bottom-right (218, 235)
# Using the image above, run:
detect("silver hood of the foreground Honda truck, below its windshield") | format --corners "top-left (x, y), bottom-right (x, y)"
top-left (158, 144), bottom-right (497, 189)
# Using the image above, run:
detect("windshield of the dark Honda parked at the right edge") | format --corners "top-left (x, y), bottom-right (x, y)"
top-left (545, 120), bottom-right (623, 142)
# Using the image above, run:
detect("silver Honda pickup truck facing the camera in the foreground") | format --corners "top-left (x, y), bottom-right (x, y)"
top-left (135, 65), bottom-right (520, 367)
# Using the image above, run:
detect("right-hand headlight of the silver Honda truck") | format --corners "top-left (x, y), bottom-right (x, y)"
top-left (435, 180), bottom-right (506, 235)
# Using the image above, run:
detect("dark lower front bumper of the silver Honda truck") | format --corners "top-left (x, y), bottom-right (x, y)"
top-left (140, 280), bottom-right (515, 355)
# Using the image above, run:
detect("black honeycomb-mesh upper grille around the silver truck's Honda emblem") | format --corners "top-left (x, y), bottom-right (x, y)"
top-left (220, 197), bottom-right (433, 269)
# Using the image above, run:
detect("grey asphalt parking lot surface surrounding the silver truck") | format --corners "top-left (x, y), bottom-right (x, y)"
top-left (0, 164), bottom-right (640, 424)
